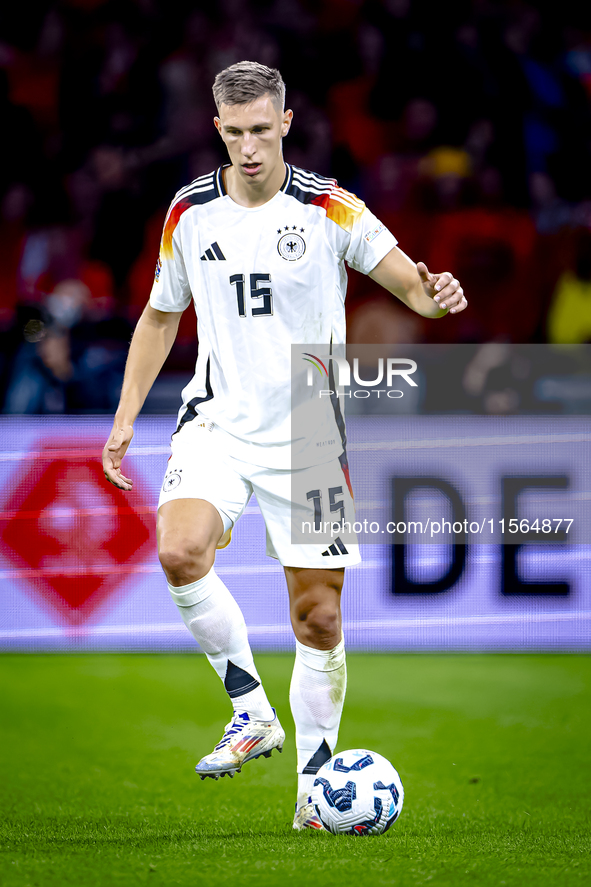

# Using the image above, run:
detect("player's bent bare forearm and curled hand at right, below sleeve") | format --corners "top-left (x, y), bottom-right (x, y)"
top-left (369, 246), bottom-right (468, 317)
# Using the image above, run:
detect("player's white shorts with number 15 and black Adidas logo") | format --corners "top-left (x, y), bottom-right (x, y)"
top-left (158, 416), bottom-right (361, 570)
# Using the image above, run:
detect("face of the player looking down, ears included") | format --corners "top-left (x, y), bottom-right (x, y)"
top-left (214, 96), bottom-right (293, 184)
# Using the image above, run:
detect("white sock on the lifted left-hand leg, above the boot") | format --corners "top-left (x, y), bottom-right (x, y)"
top-left (168, 567), bottom-right (274, 720)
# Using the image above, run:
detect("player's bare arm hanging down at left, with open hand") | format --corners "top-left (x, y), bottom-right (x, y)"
top-left (103, 303), bottom-right (183, 490)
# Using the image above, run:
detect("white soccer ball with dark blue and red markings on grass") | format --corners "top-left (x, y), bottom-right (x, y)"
top-left (312, 748), bottom-right (404, 835)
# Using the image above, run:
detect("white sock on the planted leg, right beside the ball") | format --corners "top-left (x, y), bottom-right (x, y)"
top-left (289, 640), bottom-right (347, 807)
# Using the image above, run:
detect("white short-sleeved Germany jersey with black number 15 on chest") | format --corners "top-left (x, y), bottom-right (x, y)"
top-left (150, 164), bottom-right (396, 468)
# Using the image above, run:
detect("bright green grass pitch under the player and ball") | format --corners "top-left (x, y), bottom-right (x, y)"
top-left (0, 655), bottom-right (591, 887)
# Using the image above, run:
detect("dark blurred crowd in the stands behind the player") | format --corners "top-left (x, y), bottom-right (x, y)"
top-left (0, 0), bottom-right (591, 413)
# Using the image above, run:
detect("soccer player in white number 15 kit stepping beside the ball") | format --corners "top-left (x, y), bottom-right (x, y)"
top-left (103, 62), bottom-right (467, 829)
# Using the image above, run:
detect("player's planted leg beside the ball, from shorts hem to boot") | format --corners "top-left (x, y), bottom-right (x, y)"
top-left (285, 567), bottom-right (347, 829)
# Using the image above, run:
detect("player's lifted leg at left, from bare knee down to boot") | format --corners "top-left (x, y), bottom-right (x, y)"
top-left (158, 499), bottom-right (285, 779)
